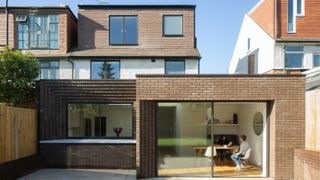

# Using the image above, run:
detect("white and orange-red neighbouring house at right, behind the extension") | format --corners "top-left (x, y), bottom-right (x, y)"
top-left (228, 0), bottom-right (320, 74)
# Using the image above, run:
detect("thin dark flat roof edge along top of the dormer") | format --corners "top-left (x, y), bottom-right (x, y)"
top-left (78, 4), bottom-right (196, 9)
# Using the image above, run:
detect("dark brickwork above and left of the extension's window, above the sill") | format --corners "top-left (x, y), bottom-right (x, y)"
top-left (39, 80), bottom-right (136, 140)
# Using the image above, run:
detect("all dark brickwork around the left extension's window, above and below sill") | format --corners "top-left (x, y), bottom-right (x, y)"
top-left (39, 80), bottom-right (136, 169)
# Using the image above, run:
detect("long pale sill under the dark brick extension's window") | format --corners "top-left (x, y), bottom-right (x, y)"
top-left (40, 139), bottom-right (136, 144)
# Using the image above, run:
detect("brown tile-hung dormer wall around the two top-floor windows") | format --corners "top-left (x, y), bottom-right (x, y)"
top-left (78, 8), bottom-right (194, 49)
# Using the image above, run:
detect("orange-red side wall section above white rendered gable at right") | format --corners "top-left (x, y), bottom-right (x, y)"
top-left (250, 0), bottom-right (275, 37)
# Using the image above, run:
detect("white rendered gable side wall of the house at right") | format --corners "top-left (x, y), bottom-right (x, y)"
top-left (228, 15), bottom-right (274, 74)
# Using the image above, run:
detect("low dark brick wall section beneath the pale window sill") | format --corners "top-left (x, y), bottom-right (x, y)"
top-left (40, 144), bottom-right (136, 169)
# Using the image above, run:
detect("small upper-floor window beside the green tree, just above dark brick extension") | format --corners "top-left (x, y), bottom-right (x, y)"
top-left (40, 61), bottom-right (59, 79)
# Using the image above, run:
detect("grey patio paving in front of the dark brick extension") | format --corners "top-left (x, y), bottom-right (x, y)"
top-left (19, 169), bottom-right (136, 180)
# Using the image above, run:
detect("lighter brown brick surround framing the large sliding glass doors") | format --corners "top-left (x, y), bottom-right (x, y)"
top-left (136, 75), bottom-right (305, 179)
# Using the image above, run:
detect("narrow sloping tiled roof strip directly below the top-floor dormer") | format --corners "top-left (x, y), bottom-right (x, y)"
top-left (69, 48), bottom-right (201, 59)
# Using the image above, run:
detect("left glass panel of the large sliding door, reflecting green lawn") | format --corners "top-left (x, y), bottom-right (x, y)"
top-left (157, 102), bottom-right (212, 177)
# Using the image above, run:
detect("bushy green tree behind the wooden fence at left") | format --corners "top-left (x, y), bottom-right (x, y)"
top-left (0, 47), bottom-right (39, 106)
